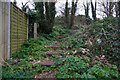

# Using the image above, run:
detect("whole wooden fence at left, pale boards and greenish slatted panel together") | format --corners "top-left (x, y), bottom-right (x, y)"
top-left (0, 1), bottom-right (27, 61)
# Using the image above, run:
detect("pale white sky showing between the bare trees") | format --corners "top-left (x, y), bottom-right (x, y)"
top-left (11, 0), bottom-right (119, 18)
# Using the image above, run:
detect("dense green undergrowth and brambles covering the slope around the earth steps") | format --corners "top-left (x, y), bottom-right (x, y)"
top-left (2, 18), bottom-right (120, 79)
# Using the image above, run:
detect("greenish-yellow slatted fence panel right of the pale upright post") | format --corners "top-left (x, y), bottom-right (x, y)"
top-left (10, 3), bottom-right (27, 54)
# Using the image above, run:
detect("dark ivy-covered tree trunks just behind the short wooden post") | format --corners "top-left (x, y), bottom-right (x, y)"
top-left (35, 2), bottom-right (56, 34)
